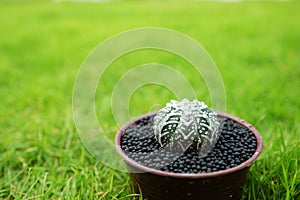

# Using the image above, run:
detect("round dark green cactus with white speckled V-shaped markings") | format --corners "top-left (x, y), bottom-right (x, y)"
top-left (154, 99), bottom-right (220, 154)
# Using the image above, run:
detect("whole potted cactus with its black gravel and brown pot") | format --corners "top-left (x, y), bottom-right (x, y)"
top-left (115, 99), bottom-right (262, 200)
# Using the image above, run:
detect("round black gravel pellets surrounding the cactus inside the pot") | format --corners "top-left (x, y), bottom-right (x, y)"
top-left (121, 117), bottom-right (257, 173)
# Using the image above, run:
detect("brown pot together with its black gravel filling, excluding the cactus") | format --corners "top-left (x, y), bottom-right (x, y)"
top-left (115, 112), bottom-right (263, 200)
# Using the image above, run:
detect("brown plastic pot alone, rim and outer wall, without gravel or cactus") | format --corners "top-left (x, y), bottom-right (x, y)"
top-left (115, 113), bottom-right (263, 200)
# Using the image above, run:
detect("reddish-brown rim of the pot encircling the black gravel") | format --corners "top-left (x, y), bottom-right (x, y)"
top-left (115, 112), bottom-right (263, 179)
